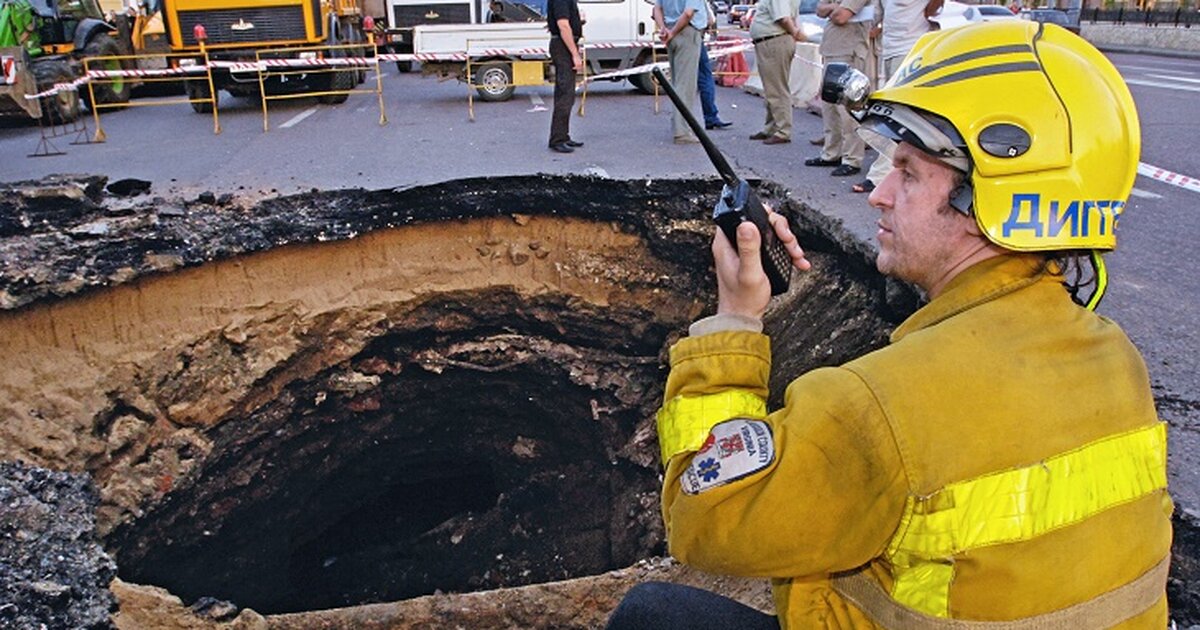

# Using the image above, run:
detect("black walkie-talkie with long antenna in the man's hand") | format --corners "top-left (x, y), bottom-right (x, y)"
top-left (650, 67), bottom-right (792, 295)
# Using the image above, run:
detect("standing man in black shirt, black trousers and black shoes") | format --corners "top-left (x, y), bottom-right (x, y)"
top-left (546, 0), bottom-right (583, 154)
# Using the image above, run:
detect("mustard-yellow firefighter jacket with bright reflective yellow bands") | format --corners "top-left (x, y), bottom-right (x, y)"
top-left (659, 254), bottom-right (1172, 630)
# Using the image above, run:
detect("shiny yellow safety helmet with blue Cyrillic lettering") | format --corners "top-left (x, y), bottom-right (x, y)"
top-left (860, 20), bottom-right (1141, 253)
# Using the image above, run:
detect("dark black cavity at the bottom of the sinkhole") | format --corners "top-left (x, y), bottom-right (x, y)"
top-left (109, 300), bottom-right (661, 613)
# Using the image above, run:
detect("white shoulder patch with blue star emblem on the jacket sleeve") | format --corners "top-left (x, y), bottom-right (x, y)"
top-left (679, 418), bottom-right (775, 494)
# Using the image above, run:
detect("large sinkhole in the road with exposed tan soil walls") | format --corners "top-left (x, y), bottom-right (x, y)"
top-left (2, 176), bottom-right (914, 613)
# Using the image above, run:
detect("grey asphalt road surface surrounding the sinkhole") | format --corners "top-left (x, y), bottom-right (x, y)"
top-left (0, 44), bottom-right (1200, 509)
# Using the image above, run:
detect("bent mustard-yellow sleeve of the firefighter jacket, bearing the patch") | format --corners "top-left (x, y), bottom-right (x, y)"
top-left (659, 332), bottom-right (907, 577)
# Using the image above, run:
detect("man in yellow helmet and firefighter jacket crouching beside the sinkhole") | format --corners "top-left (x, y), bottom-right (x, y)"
top-left (610, 22), bottom-right (1172, 630)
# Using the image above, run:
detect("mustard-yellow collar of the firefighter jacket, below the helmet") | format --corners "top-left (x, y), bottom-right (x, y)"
top-left (892, 253), bottom-right (1046, 343)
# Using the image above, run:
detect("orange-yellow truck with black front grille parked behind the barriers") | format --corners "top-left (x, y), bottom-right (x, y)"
top-left (163, 0), bottom-right (366, 113)
